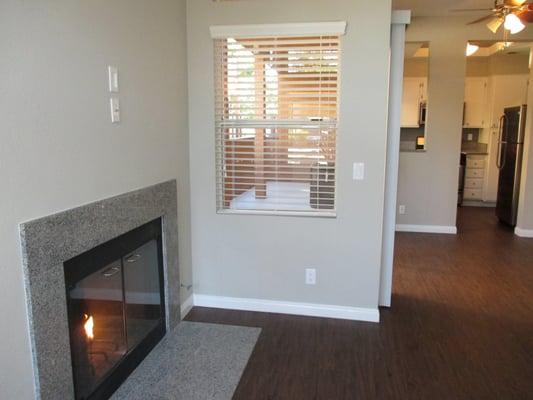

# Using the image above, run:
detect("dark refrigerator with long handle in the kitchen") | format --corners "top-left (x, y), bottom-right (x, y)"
top-left (496, 105), bottom-right (526, 226)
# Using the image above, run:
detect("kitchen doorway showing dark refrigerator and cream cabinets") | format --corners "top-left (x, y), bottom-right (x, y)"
top-left (457, 41), bottom-right (533, 231)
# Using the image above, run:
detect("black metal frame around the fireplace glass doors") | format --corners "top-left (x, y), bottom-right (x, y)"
top-left (63, 218), bottom-right (166, 400)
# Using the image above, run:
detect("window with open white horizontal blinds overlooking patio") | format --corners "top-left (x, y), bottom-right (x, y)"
top-left (215, 28), bottom-right (341, 214)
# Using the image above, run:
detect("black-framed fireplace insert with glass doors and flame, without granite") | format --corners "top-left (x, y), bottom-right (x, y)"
top-left (64, 219), bottom-right (166, 400)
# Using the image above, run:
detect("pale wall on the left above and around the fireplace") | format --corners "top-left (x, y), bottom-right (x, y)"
top-left (0, 0), bottom-right (191, 400)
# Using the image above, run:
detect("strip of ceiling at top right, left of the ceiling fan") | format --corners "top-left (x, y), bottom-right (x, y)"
top-left (392, 0), bottom-right (494, 17)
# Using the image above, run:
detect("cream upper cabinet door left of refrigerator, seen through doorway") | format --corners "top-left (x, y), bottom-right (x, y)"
top-left (464, 78), bottom-right (487, 128)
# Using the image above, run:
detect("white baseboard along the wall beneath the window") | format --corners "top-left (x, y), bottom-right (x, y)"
top-left (194, 294), bottom-right (379, 322)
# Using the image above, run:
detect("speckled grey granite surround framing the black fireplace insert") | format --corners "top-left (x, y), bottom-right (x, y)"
top-left (20, 180), bottom-right (180, 400)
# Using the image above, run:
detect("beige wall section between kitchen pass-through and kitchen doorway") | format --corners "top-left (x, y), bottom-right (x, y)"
top-left (397, 17), bottom-right (533, 227)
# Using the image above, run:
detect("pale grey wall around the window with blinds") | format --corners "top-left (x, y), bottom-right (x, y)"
top-left (187, 0), bottom-right (391, 308)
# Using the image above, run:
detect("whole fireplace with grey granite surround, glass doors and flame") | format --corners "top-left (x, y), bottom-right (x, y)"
top-left (20, 180), bottom-right (180, 400)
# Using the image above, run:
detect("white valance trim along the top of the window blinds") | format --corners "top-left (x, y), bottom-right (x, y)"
top-left (209, 21), bottom-right (347, 39)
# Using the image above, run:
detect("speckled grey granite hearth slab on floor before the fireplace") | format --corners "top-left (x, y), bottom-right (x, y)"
top-left (111, 321), bottom-right (261, 400)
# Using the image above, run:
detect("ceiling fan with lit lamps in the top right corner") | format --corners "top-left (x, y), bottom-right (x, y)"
top-left (453, 0), bottom-right (533, 34)
